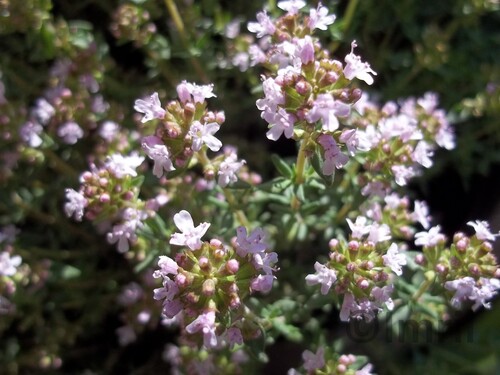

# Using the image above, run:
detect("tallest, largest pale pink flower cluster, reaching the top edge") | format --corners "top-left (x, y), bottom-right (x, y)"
top-left (248, 1), bottom-right (376, 175)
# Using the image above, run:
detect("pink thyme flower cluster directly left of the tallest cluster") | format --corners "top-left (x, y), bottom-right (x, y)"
top-left (134, 81), bottom-right (245, 187)
